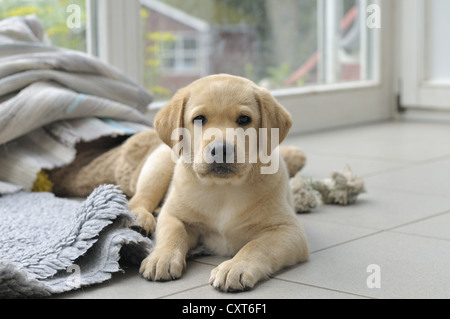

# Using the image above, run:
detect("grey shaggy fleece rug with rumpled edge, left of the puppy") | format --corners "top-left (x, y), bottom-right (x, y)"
top-left (0, 185), bottom-right (152, 298)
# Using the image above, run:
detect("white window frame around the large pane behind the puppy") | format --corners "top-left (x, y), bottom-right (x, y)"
top-left (93, 0), bottom-right (397, 134)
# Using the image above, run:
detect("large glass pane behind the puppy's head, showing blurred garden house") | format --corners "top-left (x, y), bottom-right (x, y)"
top-left (141, 0), bottom-right (374, 99)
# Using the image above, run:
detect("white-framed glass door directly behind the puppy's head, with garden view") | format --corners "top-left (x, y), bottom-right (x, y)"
top-left (136, 0), bottom-right (395, 133)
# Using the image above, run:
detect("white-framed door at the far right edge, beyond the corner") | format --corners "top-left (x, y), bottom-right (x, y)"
top-left (400, 0), bottom-right (450, 110)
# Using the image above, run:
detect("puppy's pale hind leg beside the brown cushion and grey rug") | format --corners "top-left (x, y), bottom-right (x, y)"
top-left (129, 144), bottom-right (175, 234)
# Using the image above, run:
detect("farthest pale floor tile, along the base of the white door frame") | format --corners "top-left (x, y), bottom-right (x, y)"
top-left (283, 122), bottom-right (450, 162)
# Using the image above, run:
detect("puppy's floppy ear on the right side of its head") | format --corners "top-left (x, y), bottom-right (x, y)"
top-left (255, 87), bottom-right (292, 149)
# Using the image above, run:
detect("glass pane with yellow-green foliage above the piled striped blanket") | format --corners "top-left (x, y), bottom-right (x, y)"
top-left (0, 0), bottom-right (86, 52)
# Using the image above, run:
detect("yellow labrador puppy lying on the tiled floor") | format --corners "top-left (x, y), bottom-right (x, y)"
top-left (134, 75), bottom-right (309, 291)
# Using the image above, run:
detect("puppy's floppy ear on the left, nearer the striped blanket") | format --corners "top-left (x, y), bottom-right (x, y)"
top-left (153, 88), bottom-right (189, 147)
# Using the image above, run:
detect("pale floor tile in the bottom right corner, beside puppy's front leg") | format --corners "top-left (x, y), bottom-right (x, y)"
top-left (276, 232), bottom-right (450, 298)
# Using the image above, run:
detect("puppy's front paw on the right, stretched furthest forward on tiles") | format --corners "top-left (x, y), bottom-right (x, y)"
top-left (209, 259), bottom-right (262, 292)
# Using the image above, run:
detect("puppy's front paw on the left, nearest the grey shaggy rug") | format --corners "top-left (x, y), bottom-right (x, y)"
top-left (139, 250), bottom-right (186, 281)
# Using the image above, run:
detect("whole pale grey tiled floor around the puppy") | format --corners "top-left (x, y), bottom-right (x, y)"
top-left (59, 122), bottom-right (450, 299)
